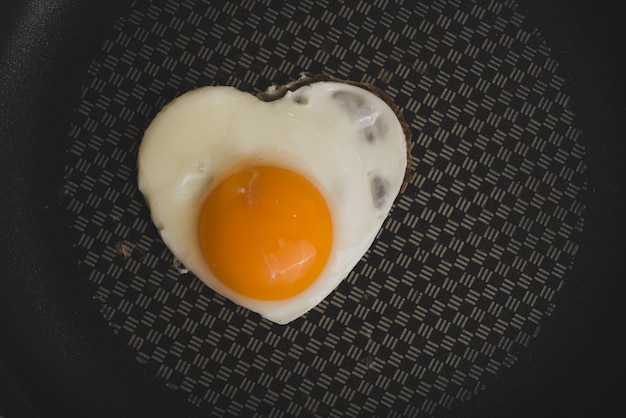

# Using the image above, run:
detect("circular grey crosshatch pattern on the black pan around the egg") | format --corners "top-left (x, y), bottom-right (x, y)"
top-left (64, 0), bottom-right (585, 416)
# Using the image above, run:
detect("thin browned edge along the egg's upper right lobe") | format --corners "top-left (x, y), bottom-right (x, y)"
top-left (256, 73), bottom-right (413, 192)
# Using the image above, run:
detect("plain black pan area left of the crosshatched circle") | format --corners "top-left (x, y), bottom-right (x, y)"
top-left (0, 1), bottom-right (207, 417)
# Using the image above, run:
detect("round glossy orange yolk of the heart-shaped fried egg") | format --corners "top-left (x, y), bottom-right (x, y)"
top-left (199, 166), bottom-right (332, 300)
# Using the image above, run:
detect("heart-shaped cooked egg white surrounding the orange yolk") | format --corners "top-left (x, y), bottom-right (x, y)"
top-left (138, 82), bottom-right (407, 324)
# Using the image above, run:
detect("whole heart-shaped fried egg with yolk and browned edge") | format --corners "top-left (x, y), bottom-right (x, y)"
top-left (138, 75), bottom-right (410, 324)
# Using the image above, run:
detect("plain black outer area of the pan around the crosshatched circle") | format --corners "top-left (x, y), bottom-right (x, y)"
top-left (0, 1), bottom-right (626, 418)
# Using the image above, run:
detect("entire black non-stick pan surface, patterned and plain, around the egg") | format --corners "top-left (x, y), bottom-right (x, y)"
top-left (0, 1), bottom-right (624, 416)
